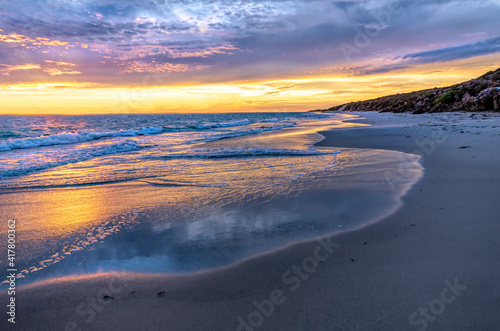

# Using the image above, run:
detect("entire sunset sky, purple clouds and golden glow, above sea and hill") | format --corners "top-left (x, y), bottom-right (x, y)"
top-left (0, 0), bottom-right (500, 114)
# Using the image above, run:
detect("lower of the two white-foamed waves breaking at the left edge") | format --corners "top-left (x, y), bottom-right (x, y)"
top-left (0, 140), bottom-right (146, 179)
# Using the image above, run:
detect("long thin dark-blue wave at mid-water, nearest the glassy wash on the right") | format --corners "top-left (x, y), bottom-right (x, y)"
top-left (143, 148), bottom-right (340, 160)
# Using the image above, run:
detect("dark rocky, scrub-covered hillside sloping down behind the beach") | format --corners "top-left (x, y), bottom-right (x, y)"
top-left (313, 68), bottom-right (500, 114)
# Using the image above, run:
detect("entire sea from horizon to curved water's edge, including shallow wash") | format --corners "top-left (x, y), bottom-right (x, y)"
top-left (0, 113), bottom-right (421, 282)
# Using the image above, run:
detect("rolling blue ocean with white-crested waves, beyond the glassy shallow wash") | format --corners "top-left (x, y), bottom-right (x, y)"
top-left (0, 113), bottom-right (324, 188)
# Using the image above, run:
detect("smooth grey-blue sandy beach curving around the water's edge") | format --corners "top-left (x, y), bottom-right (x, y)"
top-left (0, 112), bottom-right (500, 331)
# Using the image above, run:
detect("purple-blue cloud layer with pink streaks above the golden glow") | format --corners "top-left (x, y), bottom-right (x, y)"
top-left (0, 0), bottom-right (500, 84)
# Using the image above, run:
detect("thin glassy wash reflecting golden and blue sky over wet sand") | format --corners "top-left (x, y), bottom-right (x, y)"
top-left (0, 113), bottom-right (422, 282)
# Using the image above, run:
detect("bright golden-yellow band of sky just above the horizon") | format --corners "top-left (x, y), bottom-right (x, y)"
top-left (0, 55), bottom-right (500, 114)
